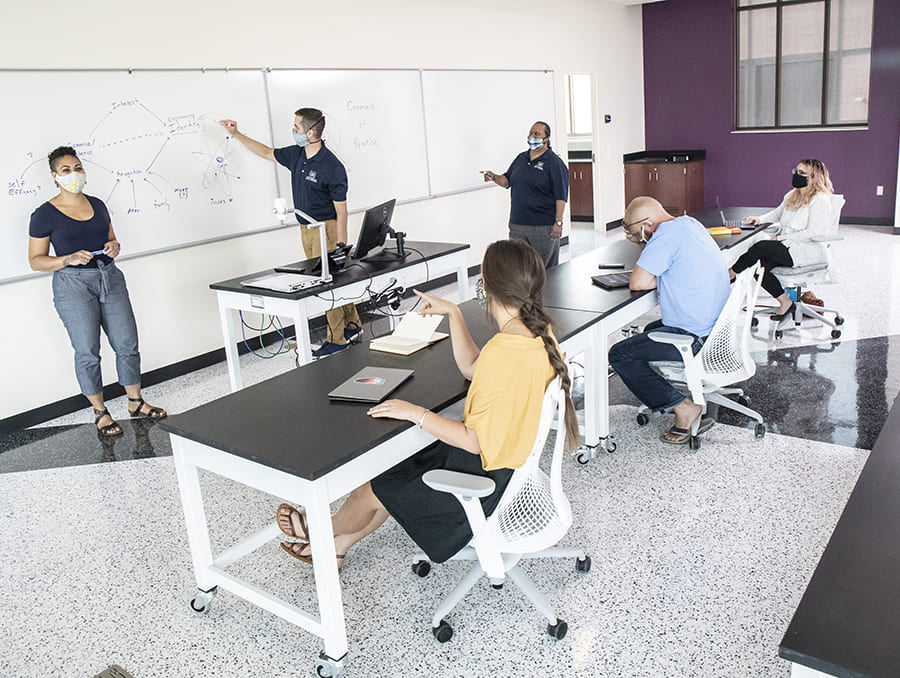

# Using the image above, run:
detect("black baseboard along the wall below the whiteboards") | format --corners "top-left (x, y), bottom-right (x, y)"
top-left (0, 266), bottom-right (481, 434)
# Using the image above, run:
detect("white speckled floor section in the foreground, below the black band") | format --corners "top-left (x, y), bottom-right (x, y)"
top-left (0, 406), bottom-right (866, 678)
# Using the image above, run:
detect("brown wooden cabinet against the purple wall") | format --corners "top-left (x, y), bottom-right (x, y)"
top-left (625, 158), bottom-right (704, 217)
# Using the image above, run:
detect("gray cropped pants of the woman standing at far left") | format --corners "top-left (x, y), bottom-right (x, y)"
top-left (53, 263), bottom-right (141, 395)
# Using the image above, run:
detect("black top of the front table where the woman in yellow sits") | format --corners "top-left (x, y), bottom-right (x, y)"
top-left (160, 300), bottom-right (596, 480)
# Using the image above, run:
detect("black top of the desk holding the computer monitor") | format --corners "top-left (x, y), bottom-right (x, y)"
top-left (209, 240), bottom-right (469, 299)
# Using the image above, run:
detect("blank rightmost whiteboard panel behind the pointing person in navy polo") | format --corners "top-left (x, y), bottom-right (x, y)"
top-left (422, 70), bottom-right (566, 195)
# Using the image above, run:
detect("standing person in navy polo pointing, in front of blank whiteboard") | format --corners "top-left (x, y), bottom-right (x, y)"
top-left (483, 121), bottom-right (569, 268)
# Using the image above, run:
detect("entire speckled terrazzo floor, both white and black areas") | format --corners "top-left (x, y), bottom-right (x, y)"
top-left (0, 227), bottom-right (900, 678)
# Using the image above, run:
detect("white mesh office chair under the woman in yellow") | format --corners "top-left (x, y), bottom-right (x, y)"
top-left (413, 377), bottom-right (591, 643)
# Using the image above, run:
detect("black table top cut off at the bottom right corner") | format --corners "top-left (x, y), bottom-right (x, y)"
top-left (779, 390), bottom-right (900, 678)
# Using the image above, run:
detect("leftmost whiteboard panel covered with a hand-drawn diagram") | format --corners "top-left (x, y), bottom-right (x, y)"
top-left (0, 70), bottom-right (276, 279)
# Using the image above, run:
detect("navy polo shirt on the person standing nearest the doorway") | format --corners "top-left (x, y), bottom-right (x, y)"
top-left (505, 148), bottom-right (569, 226)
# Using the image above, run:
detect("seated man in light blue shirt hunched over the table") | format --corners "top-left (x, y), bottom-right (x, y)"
top-left (609, 197), bottom-right (731, 444)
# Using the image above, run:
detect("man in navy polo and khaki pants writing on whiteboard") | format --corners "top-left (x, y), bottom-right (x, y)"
top-left (220, 108), bottom-right (362, 358)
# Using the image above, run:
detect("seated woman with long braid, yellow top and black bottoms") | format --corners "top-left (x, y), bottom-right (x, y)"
top-left (277, 240), bottom-right (578, 569)
